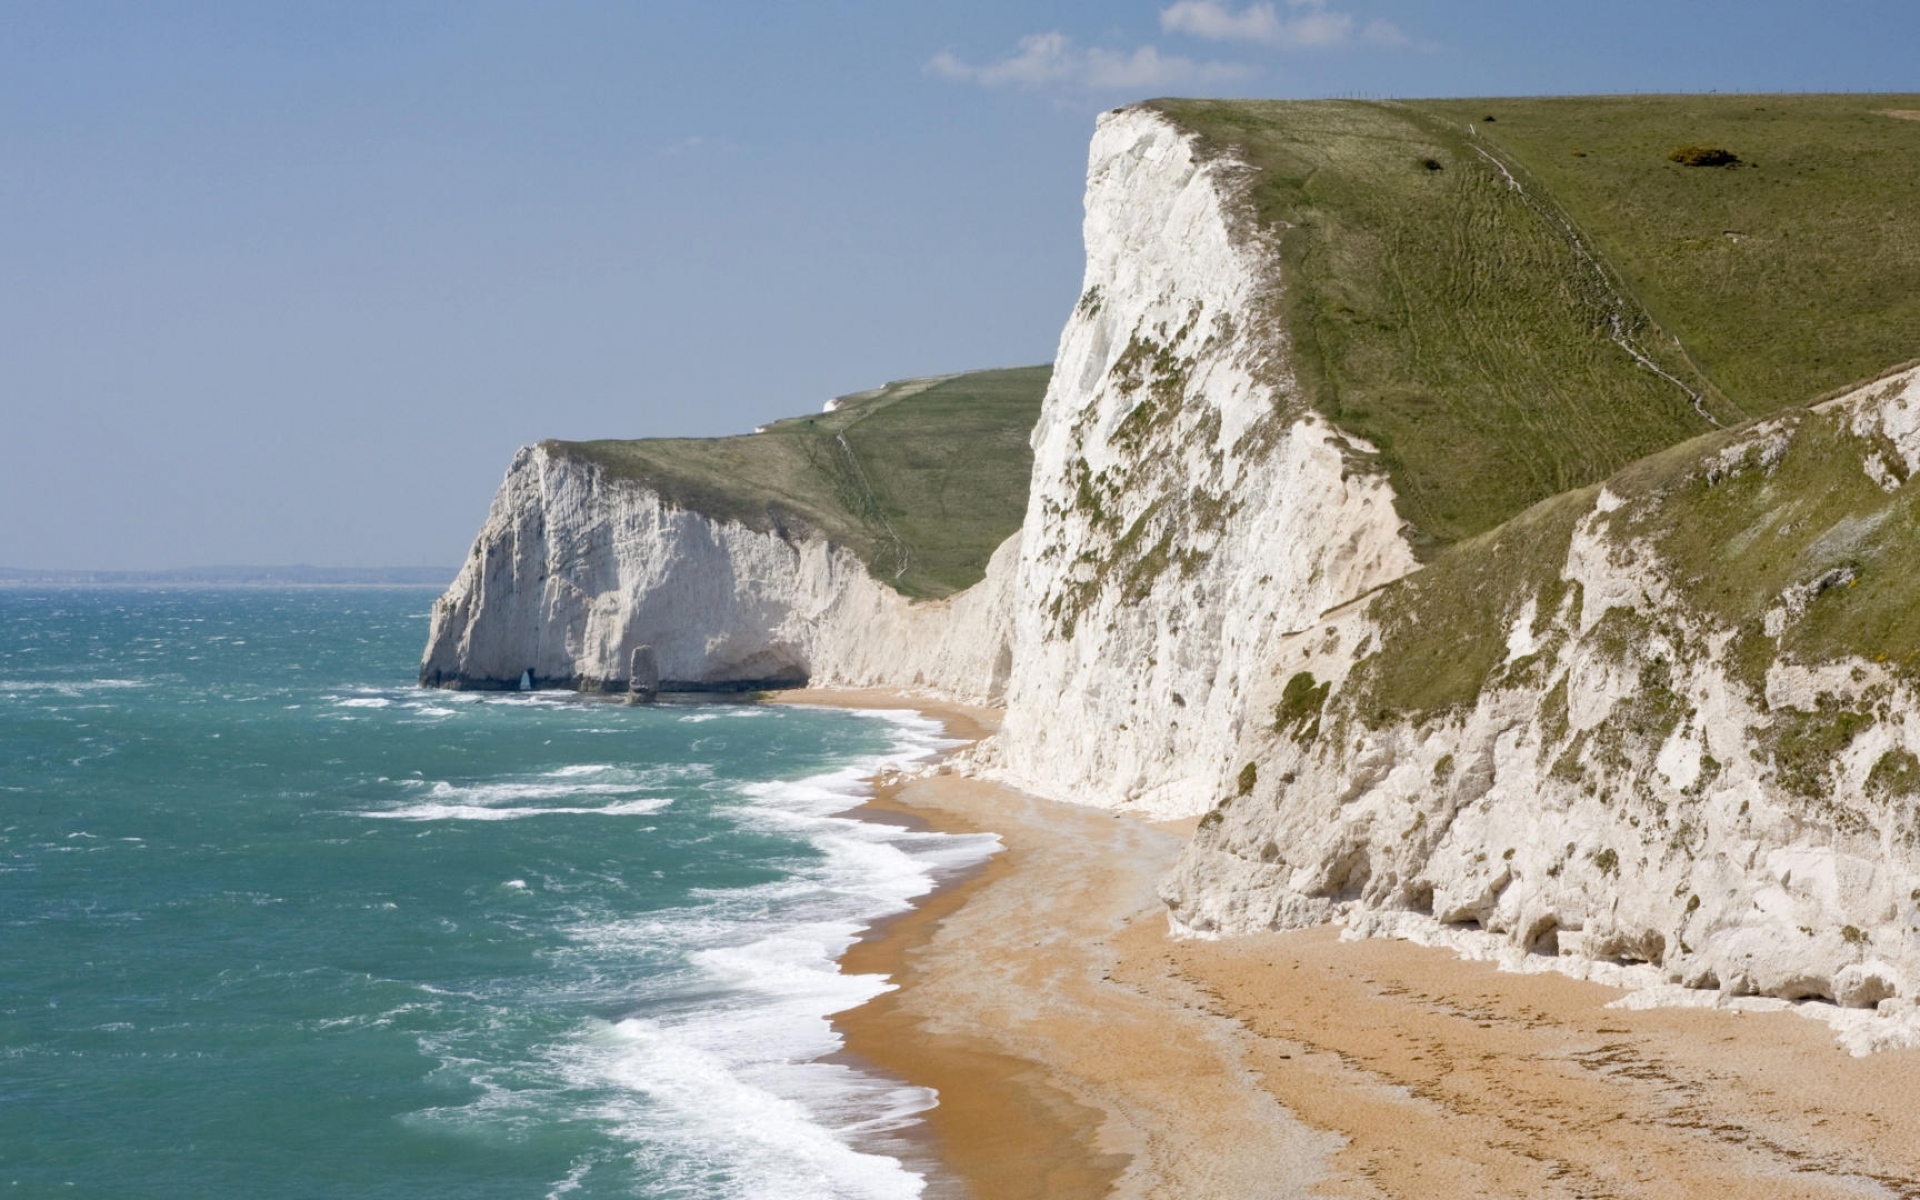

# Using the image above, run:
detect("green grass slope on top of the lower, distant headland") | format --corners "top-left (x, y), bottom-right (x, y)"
top-left (547, 367), bottom-right (1052, 597)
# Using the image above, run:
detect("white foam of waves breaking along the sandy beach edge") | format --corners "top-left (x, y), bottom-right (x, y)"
top-left (403, 708), bottom-right (998, 1200)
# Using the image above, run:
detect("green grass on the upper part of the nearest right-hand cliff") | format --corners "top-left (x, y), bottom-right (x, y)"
top-left (1348, 378), bottom-right (1920, 726)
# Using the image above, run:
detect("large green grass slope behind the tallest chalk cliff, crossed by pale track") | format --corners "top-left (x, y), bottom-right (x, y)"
top-left (1154, 96), bottom-right (1920, 553)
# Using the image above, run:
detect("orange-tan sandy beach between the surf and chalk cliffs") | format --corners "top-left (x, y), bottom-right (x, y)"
top-left (781, 691), bottom-right (1920, 1200)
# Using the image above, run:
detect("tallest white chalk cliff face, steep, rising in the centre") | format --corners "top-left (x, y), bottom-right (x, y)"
top-left (1000, 109), bottom-right (1415, 816)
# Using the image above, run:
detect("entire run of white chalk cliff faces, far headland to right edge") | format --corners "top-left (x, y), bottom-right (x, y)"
top-left (420, 109), bottom-right (1920, 1036)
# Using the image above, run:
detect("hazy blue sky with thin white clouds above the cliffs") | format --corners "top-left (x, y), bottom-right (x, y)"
top-left (11, 0), bottom-right (1920, 570)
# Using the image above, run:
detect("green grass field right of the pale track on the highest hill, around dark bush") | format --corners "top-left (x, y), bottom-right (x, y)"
top-left (1419, 96), bottom-right (1920, 417)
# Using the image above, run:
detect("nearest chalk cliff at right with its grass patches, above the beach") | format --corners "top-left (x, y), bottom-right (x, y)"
top-left (1165, 371), bottom-right (1920, 1006)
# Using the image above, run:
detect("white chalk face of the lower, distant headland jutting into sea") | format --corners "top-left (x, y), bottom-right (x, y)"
top-left (420, 445), bottom-right (1020, 703)
